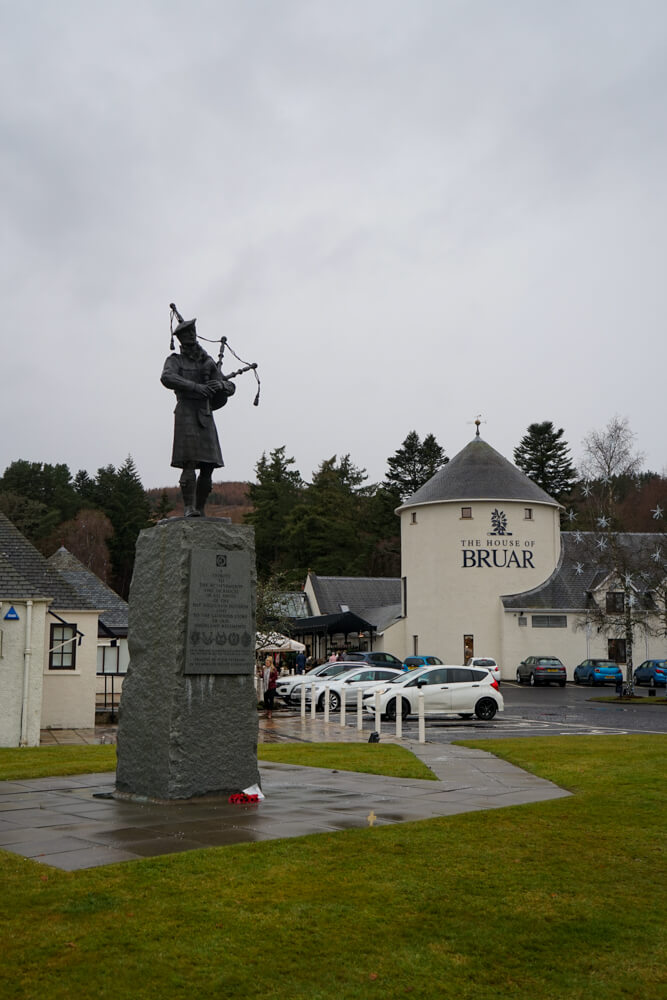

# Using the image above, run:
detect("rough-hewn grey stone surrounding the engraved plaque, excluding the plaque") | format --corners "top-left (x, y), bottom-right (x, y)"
top-left (116, 518), bottom-right (259, 799)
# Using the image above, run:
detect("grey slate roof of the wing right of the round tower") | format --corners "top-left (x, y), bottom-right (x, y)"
top-left (501, 531), bottom-right (665, 611)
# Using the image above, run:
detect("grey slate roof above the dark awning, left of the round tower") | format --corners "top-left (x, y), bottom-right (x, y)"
top-left (310, 573), bottom-right (401, 631)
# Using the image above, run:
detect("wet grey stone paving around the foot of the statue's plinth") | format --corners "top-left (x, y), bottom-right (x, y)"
top-left (0, 715), bottom-right (568, 871)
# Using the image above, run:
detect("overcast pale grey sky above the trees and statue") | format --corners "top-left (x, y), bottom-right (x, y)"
top-left (0, 0), bottom-right (667, 487)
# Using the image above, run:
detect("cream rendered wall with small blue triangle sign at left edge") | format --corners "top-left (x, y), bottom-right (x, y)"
top-left (0, 600), bottom-right (49, 747)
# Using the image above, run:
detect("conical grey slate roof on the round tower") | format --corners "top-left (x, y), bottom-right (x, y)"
top-left (398, 437), bottom-right (559, 511)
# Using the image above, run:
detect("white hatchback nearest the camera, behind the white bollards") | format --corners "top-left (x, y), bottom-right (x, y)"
top-left (364, 665), bottom-right (505, 720)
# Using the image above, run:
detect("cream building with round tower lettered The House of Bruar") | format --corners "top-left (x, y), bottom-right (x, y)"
top-left (297, 429), bottom-right (667, 678)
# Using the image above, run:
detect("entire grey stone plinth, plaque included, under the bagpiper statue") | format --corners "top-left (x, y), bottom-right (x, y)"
top-left (116, 518), bottom-right (259, 800)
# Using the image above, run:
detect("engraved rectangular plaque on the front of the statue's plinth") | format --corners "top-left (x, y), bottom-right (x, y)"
top-left (184, 548), bottom-right (255, 674)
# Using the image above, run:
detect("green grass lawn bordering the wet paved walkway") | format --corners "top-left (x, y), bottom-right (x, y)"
top-left (0, 736), bottom-right (667, 1000)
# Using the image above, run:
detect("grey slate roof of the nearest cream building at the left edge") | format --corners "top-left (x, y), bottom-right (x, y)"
top-left (0, 513), bottom-right (97, 611)
